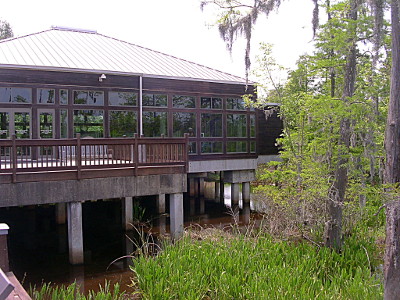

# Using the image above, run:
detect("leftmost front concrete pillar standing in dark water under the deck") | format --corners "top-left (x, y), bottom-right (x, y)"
top-left (67, 202), bottom-right (83, 265)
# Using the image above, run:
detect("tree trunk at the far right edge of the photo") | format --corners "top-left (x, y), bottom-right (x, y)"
top-left (384, 0), bottom-right (400, 300)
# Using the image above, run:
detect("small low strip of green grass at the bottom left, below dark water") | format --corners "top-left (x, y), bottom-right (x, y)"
top-left (29, 282), bottom-right (129, 300)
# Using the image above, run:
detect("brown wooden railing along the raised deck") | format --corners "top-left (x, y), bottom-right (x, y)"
top-left (0, 135), bottom-right (188, 183)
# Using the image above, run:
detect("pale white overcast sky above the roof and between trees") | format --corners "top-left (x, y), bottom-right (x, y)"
top-left (0, 0), bottom-right (313, 77)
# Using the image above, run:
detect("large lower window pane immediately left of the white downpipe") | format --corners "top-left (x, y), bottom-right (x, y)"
top-left (109, 110), bottom-right (137, 137)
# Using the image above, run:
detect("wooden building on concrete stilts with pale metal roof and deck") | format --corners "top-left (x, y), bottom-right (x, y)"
top-left (0, 27), bottom-right (281, 263)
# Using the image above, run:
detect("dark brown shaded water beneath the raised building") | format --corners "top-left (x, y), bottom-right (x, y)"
top-left (0, 182), bottom-right (265, 292)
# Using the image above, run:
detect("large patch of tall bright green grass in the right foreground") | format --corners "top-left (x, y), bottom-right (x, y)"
top-left (132, 235), bottom-right (382, 299)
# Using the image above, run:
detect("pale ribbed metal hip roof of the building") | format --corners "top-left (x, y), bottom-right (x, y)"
top-left (0, 27), bottom-right (246, 84)
